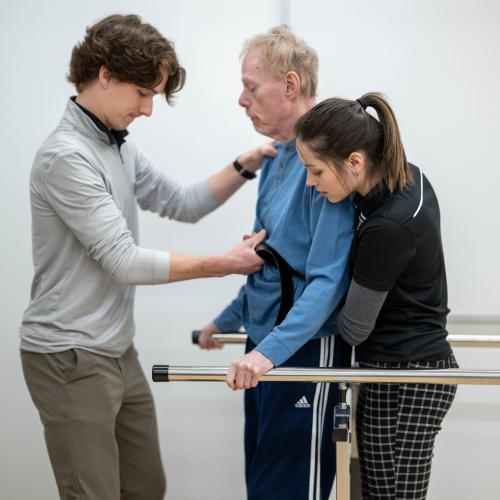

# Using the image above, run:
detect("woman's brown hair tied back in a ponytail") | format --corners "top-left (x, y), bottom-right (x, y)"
top-left (295, 92), bottom-right (412, 192)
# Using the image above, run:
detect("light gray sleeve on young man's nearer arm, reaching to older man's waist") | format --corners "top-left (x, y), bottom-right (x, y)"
top-left (43, 151), bottom-right (170, 285)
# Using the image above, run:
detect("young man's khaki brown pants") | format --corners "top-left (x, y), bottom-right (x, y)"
top-left (21, 346), bottom-right (166, 500)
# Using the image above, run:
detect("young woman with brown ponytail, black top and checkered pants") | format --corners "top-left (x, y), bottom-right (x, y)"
top-left (296, 93), bottom-right (458, 500)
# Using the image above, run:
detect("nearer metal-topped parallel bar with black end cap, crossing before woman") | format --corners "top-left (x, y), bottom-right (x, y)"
top-left (153, 365), bottom-right (500, 385)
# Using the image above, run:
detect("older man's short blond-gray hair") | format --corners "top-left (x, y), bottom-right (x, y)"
top-left (240, 24), bottom-right (318, 97)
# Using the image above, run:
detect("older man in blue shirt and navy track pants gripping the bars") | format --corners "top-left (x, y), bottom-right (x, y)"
top-left (200, 25), bottom-right (353, 500)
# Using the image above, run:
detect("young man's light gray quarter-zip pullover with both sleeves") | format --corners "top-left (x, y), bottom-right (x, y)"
top-left (20, 100), bottom-right (219, 357)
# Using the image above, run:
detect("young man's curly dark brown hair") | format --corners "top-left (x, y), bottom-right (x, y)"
top-left (67, 14), bottom-right (186, 104)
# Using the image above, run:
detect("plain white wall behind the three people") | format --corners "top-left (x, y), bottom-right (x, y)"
top-left (0, 0), bottom-right (500, 500)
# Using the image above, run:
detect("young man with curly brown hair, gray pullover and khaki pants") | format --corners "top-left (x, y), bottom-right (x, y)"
top-left (21, 15), bottom-right (274, 500)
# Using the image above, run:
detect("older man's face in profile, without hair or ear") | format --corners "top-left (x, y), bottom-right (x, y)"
top-left (238, 48), bottom-right (291, 139)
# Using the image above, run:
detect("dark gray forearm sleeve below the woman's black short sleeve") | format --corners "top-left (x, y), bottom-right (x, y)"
top-left (337, 280), bottom-right (388, 345)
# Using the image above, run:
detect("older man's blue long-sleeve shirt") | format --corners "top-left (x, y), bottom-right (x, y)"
top-left (214, 141), bottom-right (354, 366)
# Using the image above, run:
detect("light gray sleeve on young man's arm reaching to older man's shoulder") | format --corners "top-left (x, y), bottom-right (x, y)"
top-left (135, 149), bottom-right (220, 222)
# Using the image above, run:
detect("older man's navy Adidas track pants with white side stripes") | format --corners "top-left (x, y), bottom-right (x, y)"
top-left (245, 336), bottom-right (351, 500)
